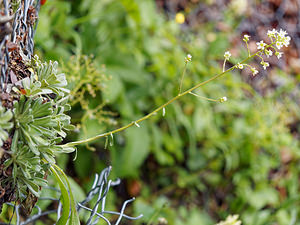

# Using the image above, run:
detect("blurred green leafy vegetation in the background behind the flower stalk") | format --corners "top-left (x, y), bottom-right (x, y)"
top-left (31, 0), bottom-right (300, 225)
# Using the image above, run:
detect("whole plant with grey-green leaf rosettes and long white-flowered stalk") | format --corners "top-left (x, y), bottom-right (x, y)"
top-left (0, 22), bottom-right (290, 224)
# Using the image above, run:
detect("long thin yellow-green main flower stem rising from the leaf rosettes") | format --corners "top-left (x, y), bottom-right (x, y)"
top-left (63, 47), bottom-right (268, 147)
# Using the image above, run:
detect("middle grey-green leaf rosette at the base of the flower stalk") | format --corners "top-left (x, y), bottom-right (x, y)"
top-left (13, 96), bottom-right (74, 163)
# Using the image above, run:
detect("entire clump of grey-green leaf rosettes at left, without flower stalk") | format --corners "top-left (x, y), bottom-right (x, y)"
top-left (0, 56), bottom-right (75, 212)
